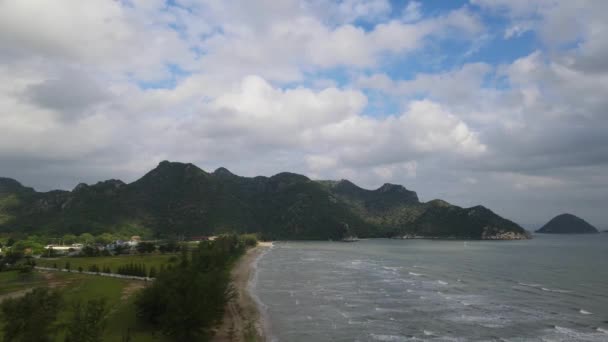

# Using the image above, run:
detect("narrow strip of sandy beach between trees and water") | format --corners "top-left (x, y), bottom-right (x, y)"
top-left (213, 242), bottom-right (272, 342)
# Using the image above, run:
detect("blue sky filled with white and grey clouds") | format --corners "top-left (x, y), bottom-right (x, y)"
top-left (0, 0), bottom-right (608, 228)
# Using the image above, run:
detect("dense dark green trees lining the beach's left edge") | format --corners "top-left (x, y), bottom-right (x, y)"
top-left (136, 235), bottom-right (245, 341)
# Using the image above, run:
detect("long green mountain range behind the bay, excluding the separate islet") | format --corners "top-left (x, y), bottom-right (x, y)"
top-left (0, 161), bottom-right (529, 239)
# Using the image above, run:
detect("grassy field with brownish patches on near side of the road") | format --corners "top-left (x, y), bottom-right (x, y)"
top-left (0, 272), bottom-right (165, 342)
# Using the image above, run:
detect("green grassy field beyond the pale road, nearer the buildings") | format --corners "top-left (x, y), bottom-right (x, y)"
top-left (36, 254), bottom-right (179, 273)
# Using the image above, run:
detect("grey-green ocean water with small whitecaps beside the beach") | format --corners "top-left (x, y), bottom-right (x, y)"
top-left (251, 234), bottom-right (608, 342)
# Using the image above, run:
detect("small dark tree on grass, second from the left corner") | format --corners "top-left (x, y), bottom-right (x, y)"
top-left (65, 298), bottom-right (107, 342)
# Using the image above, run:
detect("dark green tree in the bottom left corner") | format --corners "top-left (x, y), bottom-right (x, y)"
top-left (2, 288), bottom-right (61, 342)
